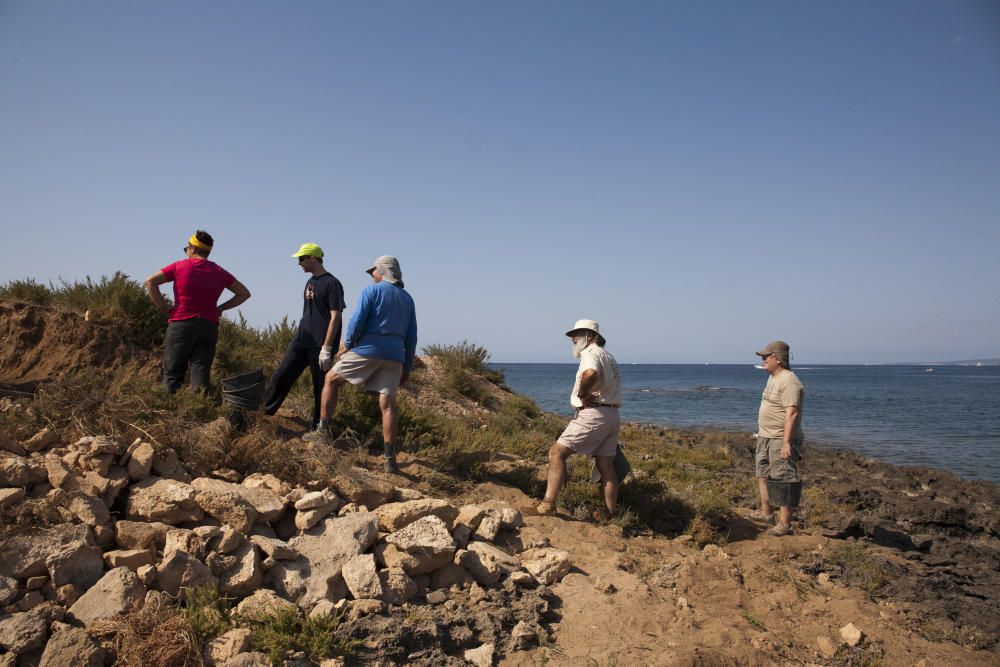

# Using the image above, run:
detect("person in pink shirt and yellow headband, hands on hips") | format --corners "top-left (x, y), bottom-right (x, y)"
top-left (146, 229), bottom-right (250, 393)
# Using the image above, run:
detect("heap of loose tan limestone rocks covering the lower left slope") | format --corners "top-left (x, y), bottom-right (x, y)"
top-left (0, 430), bottom-right (570, 666)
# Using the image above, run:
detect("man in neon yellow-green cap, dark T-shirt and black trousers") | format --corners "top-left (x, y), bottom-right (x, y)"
top-left (264, 243), bottom-right (346, 428)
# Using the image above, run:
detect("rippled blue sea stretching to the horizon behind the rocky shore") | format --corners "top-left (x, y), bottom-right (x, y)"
top-left (491, 363), bottom-right (1000, 482)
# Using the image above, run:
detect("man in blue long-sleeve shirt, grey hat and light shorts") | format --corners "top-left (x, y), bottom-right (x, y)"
top-left (307, 255), bottom-right (417, 473)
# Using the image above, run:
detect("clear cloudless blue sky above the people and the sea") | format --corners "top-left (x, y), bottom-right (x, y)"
top-left (0, 0), bottom-right (1000, 363)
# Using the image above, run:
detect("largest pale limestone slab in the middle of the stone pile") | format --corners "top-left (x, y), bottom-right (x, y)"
top-left (286, 512), bottom-right (378, 608)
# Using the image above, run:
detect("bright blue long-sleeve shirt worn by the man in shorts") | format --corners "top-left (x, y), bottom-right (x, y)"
top-left (344, 281), bottom-right (417, 372)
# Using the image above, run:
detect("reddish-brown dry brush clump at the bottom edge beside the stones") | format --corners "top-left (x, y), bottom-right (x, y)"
top-left (90, 596), bottom-right (204, 667)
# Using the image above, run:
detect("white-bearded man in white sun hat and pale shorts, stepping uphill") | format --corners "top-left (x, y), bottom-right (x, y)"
top-left (535, 320), bottom-right (622, 514)
